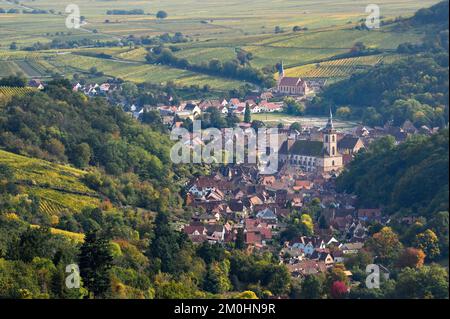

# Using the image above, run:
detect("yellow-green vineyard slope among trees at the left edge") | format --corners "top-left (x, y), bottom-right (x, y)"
top-left (0, 150), bottom-right (100, 215)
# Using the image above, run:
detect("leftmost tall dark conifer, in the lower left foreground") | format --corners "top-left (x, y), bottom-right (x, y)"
top-left (79, 232), bottom-right (113, 298)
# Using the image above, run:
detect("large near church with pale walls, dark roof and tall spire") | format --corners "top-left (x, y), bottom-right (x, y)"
top-left (279, 110), bottom-right (343, 172)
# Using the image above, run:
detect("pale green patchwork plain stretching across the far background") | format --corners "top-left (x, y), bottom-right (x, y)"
top-left (0, 0), bottom-right (438, 90)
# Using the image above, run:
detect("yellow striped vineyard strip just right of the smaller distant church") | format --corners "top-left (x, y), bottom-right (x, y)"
top-left (286, 55), bottom-right (396, 78)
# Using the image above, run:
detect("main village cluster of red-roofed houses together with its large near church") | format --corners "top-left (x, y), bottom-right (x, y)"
top-left (178, 107), bottom-right (432, 279)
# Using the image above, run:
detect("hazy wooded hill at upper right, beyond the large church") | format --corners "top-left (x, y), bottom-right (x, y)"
top-left (309, 1), bottom-right (449, 127)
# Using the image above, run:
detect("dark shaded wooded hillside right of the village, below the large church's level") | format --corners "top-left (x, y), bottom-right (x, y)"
top-left (337, 129), bottom-right (449, 217)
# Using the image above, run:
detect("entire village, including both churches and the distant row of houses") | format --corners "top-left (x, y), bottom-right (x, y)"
top-left (23, 72), bottom-right (436, 280)
